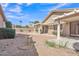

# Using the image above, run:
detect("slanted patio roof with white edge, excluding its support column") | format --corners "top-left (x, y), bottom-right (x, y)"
top-left (53, 9), bottom-right (79, 21)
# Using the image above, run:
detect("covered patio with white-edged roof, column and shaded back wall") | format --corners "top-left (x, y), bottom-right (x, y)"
top-left (53, 9), bottom-right (79, 39)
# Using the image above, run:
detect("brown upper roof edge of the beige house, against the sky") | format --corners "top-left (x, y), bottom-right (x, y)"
top-left (43, 8), bottom-right (79, 23)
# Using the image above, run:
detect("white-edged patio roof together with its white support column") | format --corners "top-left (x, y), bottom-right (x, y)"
top-left (53, 9), bottom-right (79, 39)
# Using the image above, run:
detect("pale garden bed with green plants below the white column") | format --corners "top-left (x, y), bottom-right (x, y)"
top-left (45, 38), bottom-right (79, 50)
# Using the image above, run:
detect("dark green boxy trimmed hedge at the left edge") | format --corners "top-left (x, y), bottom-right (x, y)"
top-left (0, 28), bottom-right (15, 39)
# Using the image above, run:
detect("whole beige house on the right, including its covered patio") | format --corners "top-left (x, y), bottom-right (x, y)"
top-left (35, 8), bottom-right (79, 37)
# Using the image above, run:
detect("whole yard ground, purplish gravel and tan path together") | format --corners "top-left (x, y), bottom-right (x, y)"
top-left (0, 34), bottom-right (78, 56)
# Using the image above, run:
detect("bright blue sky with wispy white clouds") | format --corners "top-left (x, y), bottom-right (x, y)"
top-left (1, 3), bottom-right (79, 26)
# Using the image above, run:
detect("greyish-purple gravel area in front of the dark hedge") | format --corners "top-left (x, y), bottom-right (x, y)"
top-left (0, 35), bottom-right (38, 56)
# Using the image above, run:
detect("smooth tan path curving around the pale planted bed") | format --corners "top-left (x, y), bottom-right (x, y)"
top-left (30, 34), bottom-right (78, 56)
